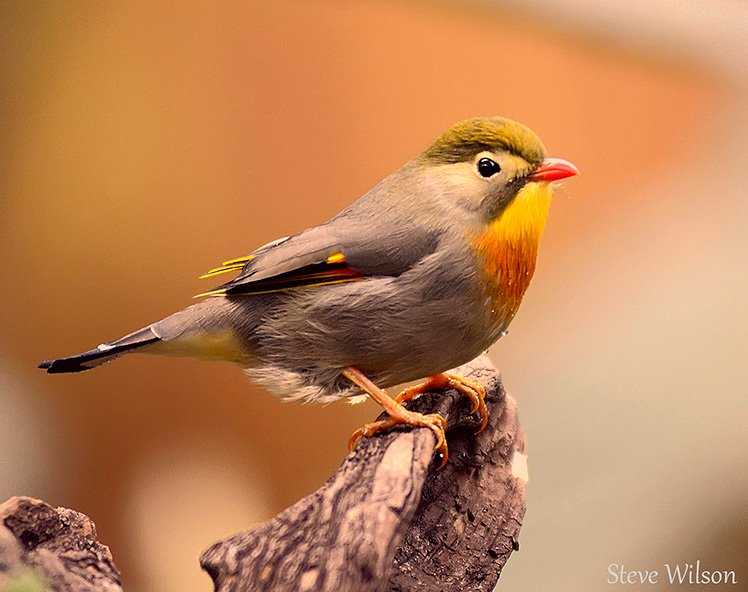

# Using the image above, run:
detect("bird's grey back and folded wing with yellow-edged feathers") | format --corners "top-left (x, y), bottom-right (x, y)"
top-left (194, 164), bottom-right (460, 296)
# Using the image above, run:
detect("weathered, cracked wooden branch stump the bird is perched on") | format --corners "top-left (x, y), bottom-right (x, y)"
top-left (201, 357), bottom-right (527, 592)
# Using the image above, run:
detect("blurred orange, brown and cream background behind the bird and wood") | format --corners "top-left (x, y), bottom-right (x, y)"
top-left (0, 0), bottom-right (748, 592)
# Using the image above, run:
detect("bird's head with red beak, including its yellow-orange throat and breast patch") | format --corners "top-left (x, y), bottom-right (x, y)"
top-left (417, 117), bottom-right (578, 312)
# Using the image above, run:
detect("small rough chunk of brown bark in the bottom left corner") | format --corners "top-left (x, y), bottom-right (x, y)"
top-left (0, 497), bottom-right (122, 592)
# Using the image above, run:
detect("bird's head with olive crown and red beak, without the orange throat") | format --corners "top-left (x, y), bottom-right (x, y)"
top-left (418, 117), bottom-right (578, 222)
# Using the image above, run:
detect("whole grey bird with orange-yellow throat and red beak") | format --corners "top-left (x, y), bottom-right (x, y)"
top-left (39, 116), bottom-right (579, 464)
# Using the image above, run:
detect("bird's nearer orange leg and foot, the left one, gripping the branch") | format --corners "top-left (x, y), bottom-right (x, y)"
top-left (343, 367), bottom-right (449, 466)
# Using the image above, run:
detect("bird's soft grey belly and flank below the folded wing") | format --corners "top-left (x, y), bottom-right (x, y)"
top-left (250, 278), bottom-right (495, 400)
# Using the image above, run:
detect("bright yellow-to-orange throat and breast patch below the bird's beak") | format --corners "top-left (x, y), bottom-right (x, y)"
top-left (472, 183), bottom-right (551, 329)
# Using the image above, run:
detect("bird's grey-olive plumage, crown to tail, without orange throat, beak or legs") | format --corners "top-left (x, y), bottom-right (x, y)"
top-left (42, 118), bottom-right (568, 401)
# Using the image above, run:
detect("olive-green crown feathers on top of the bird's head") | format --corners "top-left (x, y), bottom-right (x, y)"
top-left (422, 117), bottom-right (545, 165)
